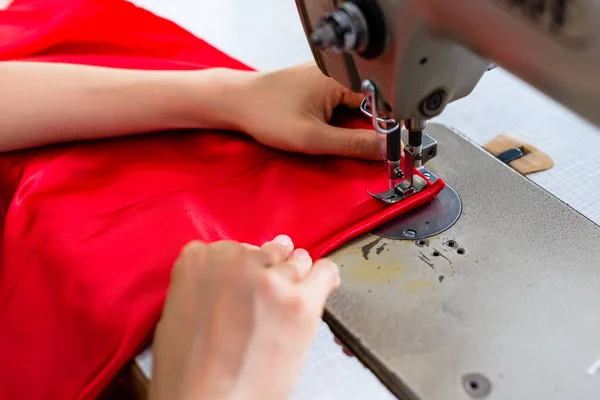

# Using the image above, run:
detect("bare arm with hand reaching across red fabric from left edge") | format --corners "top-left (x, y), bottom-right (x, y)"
top-left (0, 62), bottom-right (380, 160)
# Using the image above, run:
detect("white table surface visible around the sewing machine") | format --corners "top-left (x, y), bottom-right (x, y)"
top-left (133, 0), bottom-right (600, 400)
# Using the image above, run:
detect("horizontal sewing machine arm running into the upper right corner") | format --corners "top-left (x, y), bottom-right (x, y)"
top-left (417, 0), bottom-right (600, 126)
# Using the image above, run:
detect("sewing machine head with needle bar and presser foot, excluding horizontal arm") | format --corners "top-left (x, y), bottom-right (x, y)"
top-left (296, 0), bottom-right (489, 203)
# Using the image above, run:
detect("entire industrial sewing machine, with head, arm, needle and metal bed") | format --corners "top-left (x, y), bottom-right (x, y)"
top-left (296, 0), bottom-right (600, 400)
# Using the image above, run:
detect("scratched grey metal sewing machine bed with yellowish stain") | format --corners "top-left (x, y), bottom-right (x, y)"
top-left (327, 125), bottom-right (600, 400)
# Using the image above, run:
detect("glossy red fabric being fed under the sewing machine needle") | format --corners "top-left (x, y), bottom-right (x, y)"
top-left (0, 0), bottom-right (444, 400)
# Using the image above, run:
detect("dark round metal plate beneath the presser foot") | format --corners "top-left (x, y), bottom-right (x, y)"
top-left (373, 169), bottom-right (462, 240)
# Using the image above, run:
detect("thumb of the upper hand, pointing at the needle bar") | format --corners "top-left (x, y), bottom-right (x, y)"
top-left (314, 126), bottom-right (381, 160)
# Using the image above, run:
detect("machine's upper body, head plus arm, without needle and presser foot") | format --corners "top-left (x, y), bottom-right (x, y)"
top-left (296, 0), bottom-right (600, 125)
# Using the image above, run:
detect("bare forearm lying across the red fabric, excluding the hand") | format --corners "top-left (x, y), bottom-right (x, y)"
top-left (0, 62), bottom-right (255, 151)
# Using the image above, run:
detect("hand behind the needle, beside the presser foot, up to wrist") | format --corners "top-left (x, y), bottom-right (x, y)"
top-left (239, 62), bottom-right (381, 160)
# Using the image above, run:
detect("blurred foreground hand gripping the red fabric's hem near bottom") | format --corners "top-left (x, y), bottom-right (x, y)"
top-left (150, 236), bottom-right (340, 400)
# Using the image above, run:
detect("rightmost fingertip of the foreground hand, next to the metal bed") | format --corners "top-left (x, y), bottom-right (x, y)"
top-left (301, 259), bottom-right (340, 310)
